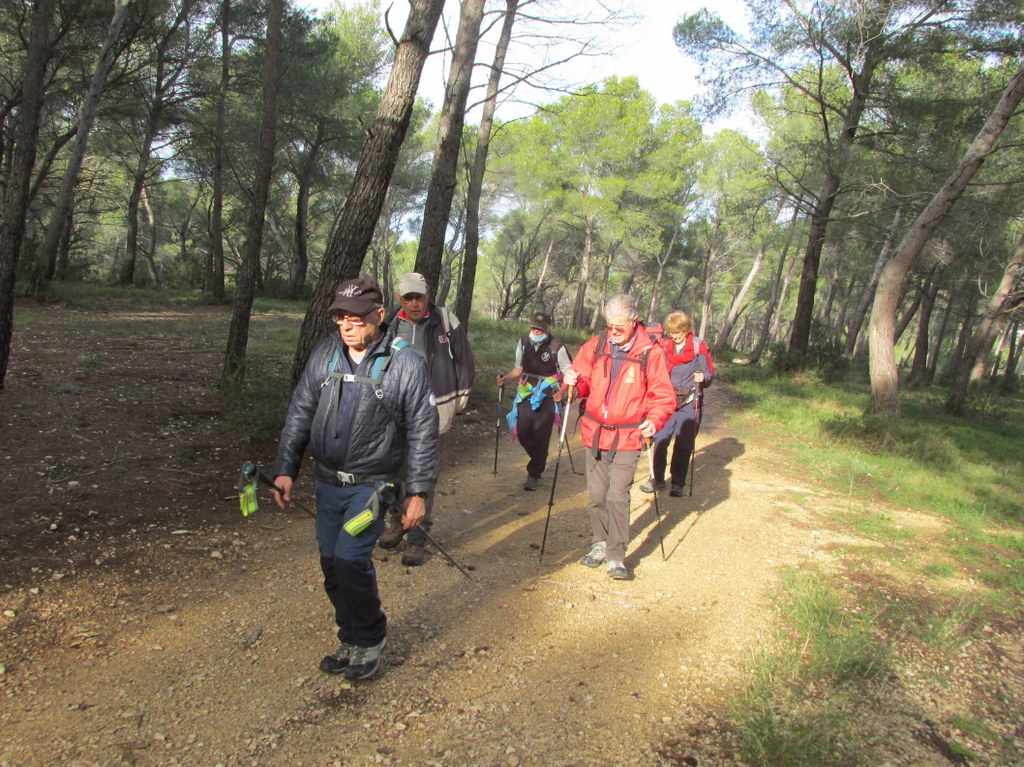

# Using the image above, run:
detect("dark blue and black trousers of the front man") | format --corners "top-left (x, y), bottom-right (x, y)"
top-left (315, 479), bottom-right (387, 647)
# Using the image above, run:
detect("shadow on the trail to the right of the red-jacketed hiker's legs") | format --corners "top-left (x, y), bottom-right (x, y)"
top-left (626, 437), bottom-right (745, 568)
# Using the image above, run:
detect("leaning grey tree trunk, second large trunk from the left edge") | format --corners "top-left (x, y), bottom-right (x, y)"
top-left (32, 0), bottom-right (128, 295)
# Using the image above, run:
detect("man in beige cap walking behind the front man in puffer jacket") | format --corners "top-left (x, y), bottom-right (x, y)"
top-left (377, 271), bottom-right (475, 567)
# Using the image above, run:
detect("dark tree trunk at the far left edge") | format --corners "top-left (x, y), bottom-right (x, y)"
top-left (0, 0), bottom-right (57, 389)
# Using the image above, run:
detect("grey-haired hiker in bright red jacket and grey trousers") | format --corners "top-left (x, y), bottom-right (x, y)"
top-left (564, 295), bottom-right (676, 581)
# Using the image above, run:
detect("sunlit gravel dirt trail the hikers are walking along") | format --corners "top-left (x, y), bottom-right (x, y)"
top-left (0, 303), bottom-right (983, 767)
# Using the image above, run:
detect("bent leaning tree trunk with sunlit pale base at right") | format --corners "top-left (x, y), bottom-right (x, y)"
top-left (868, 69), bottom-right (1024, 418)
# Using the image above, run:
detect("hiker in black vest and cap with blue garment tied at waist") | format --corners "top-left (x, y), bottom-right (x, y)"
top-left (498, 311), bottom-right (572, 491)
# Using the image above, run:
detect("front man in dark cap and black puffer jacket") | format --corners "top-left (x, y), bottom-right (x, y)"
top-left (273, 278), bottom-right (437, 680)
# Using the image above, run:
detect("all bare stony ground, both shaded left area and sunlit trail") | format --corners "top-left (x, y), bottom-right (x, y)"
top-left (0, 305), bottom-right (1022, 767)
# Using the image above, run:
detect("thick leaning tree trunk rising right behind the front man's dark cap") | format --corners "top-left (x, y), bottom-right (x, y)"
top-left (292, 0), bottom-right (444, 380)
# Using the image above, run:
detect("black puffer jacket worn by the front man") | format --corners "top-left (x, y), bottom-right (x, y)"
top-left (273, 326), bottom-right (437, 493)
